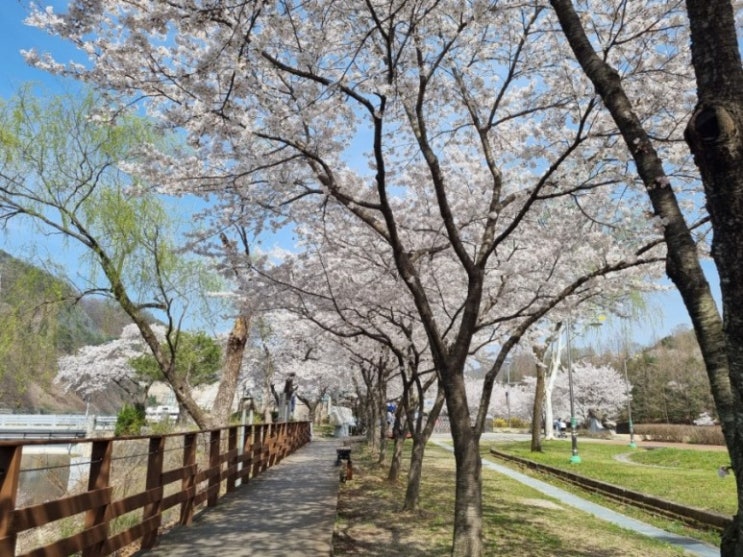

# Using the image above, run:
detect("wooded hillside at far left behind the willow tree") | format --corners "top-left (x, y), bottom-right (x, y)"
top-left (0, 250), bottom-right (130, 413)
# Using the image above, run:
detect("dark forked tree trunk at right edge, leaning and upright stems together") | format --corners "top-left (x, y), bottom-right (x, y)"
top-left (550, 0), bottom-right (743, 557)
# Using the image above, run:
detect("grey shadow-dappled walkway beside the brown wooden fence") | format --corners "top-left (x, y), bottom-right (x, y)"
top-left (136, 439), bottom-right (342, 557)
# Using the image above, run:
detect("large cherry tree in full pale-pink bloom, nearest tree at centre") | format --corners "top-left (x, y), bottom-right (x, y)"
top-left (28, 4), bottom-right (681, 557)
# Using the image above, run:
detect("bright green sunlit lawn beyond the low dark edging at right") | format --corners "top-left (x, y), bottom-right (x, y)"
top-left (483, 440), bottom-right (737, 515)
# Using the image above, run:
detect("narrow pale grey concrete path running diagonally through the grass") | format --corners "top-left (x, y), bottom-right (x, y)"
top-left (432, 439), bottom-right (720, 557)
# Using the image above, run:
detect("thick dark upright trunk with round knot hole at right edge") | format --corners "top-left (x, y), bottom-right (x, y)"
top-left (686, 0), bottom-right (743, 557)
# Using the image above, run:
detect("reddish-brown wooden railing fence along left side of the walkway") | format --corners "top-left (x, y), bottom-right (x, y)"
top-left (0, 422), bottom-right (310, 557)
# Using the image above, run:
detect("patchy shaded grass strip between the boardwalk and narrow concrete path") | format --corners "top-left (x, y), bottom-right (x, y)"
top-left (334, 445), bottom-right (708, 557)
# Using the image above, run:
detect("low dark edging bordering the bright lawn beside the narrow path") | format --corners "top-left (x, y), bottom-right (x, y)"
top-left (490, 448), bottom-right (732, 532)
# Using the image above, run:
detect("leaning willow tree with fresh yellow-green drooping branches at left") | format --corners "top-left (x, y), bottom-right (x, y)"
top-left (0, 89), bottom-right (225, 427)
